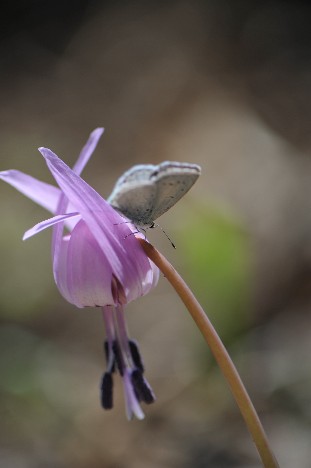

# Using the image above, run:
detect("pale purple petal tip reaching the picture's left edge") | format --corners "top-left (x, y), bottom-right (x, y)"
top-left (0, 169), bottom-right (61, 213)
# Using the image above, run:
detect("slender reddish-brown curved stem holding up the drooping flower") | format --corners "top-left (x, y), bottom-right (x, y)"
top-left (138, 238), bottom-right (279, 468)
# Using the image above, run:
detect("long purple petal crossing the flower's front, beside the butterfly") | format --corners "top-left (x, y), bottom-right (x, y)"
top-left (39, 148), bottom-right (154, 299)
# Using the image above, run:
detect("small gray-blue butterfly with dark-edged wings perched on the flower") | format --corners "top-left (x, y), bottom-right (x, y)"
top-left (108, 161), bottom-right (201, 227)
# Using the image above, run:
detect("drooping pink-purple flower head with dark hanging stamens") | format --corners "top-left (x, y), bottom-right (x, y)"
top-left (0, 128), bottom-right (159, 419)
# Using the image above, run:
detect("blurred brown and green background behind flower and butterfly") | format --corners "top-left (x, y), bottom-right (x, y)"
top-left (0, 0), bottom-right (311, 468)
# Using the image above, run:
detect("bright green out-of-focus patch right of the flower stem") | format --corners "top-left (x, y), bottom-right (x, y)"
top-left (178, 206), bottom-right (251, 342)
